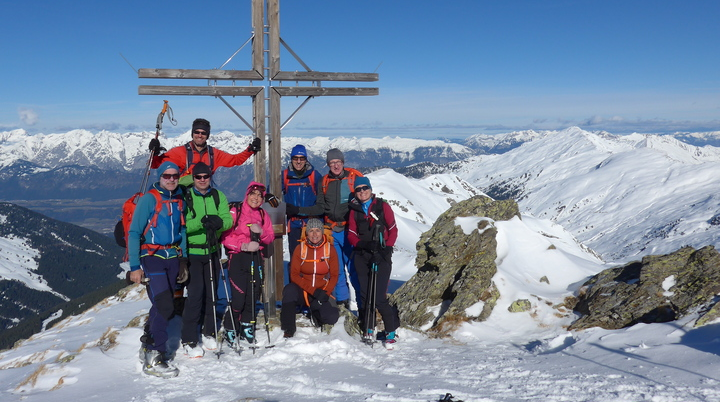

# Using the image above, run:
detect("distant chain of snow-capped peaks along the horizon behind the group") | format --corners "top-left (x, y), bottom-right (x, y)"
top-left (0, 130), bottom-right (475, 170)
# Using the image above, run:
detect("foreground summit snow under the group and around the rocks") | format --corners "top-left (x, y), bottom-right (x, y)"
top-left (0, 177), bottom-right (720, 402)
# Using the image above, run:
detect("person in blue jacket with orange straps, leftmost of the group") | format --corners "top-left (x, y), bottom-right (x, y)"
top-left (128, 162), bottom-right (187, 377)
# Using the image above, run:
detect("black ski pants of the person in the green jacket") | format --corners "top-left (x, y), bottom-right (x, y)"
top-left (180, 254), bottom-right (220, 343)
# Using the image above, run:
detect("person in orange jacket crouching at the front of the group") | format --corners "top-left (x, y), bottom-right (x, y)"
top-left (280, 218), bottom-right (340, 338)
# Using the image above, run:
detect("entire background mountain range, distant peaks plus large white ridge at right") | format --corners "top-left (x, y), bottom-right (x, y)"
top-left (0, 127), bottom-right (720, 261)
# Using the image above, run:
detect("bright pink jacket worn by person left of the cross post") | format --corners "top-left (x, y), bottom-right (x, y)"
top-left (220, 181), bottom-right (275, 254)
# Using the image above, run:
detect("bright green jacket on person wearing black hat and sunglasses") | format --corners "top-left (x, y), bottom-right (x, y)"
top-left (185, 187), bottom-right (233, 255)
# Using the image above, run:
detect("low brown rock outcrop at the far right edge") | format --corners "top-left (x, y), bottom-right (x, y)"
top-left (570, 246), bottom-right (720, 330)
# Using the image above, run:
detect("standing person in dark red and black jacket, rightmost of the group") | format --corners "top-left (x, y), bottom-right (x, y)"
top-left (348, 177), bottom-right (400, 347)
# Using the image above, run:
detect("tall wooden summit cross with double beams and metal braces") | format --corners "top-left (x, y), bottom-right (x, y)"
top-left (138, 0), bottom-right (379, 317)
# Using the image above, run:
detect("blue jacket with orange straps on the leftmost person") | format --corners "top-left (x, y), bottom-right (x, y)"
top-left (128, 183), bottom-right (187, 271)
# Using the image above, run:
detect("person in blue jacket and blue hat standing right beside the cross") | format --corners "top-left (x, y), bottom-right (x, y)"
top-left (282, 144), bottom-right (322, 285)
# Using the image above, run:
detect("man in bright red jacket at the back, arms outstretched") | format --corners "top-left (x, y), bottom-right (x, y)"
top-left (148, 119), bottom-right (261, 185)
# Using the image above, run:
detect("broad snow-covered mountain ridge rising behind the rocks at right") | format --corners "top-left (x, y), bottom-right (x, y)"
top-left (456, 128), bottom-right (720, 262)
